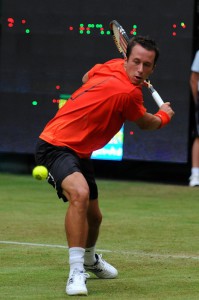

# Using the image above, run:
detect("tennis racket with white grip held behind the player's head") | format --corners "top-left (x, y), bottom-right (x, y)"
top-left (110, 20), bottom-right (164, 107)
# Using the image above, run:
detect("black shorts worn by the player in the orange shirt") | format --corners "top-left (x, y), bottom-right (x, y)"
top-left (35, 139), bottom-right (98, 202)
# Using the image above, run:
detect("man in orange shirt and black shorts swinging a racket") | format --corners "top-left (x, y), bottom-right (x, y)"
top-left (36, 37), bottom-right (174, 295)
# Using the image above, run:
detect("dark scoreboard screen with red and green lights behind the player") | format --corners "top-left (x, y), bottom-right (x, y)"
top-left (0, 0), bottom-right (195, 162)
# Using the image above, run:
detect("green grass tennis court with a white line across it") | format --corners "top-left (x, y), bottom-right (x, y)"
top-left (0, 174), bottom-right (199, 300)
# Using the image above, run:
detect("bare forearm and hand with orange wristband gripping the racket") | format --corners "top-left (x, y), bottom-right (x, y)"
top-left (135, 102), bottom-right (174, 130)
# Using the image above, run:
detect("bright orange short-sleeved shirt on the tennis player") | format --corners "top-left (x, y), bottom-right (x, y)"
top-left (40, 59), bottom-right (146, 158)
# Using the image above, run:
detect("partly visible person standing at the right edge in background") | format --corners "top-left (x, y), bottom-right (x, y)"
top-left (189, 50), bottom-right (199, 187)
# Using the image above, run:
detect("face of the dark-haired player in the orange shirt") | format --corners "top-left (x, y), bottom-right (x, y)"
top-left (124, 44), bottom-right (155, 85)
